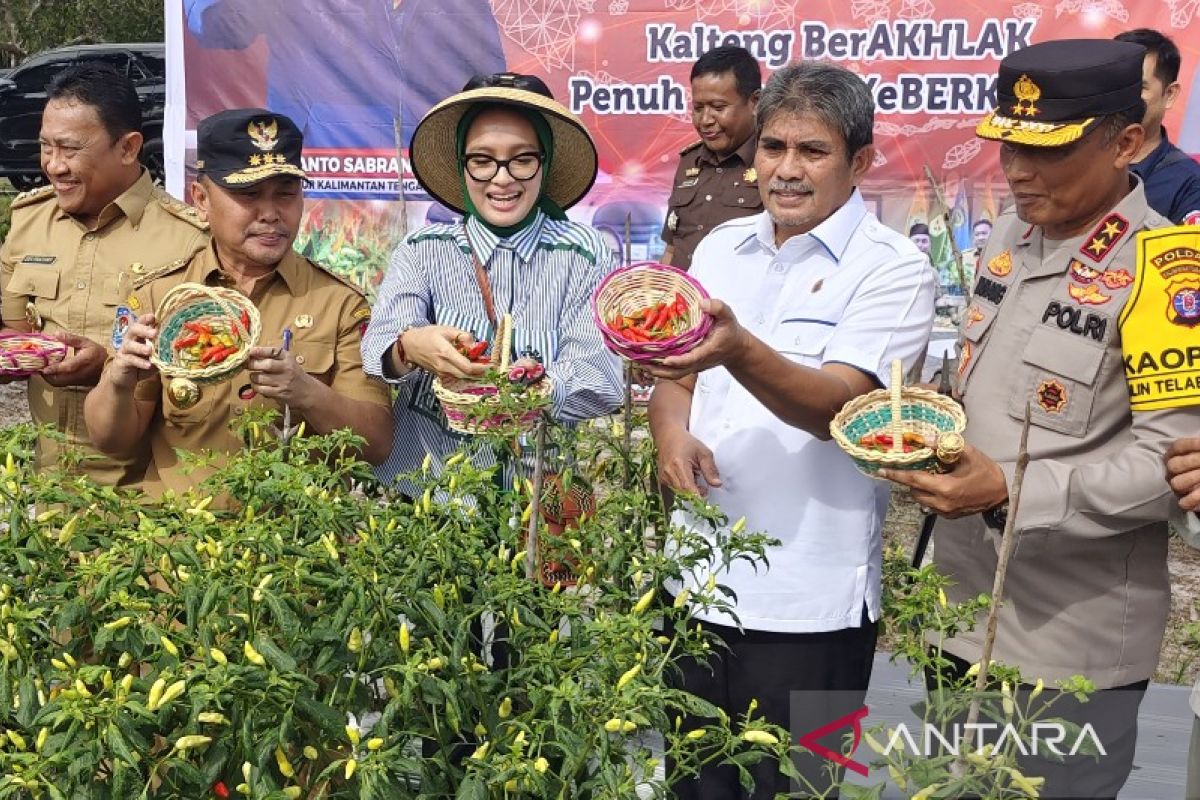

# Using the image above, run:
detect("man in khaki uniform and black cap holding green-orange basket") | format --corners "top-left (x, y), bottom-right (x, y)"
top-left (84, 108), bottom-right (391, 493)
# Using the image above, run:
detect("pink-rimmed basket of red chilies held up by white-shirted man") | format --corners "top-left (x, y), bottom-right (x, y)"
top-left (592, 261), bottom-right (713, 361)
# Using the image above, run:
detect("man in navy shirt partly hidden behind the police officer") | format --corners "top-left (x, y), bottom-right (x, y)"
top-left (1115, 28), bottom-right (1200, 224)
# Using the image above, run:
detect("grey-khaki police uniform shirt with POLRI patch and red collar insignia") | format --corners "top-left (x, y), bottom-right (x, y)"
top-left (934, 182), bottom-right (1198, 688)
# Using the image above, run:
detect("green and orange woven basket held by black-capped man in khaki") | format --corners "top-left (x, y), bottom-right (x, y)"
top-left (150, 283), bottom-right (263, 384)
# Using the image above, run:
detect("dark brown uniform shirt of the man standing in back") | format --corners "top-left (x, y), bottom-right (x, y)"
top-left (660, 137), bottom-right (762, 270)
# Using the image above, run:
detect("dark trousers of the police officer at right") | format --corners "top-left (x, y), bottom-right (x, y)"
top-left (925, 652), bottom-right (1150, 800)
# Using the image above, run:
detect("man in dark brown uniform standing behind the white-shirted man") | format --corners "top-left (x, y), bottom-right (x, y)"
top-left (660, 46), bottom-right (762, 270)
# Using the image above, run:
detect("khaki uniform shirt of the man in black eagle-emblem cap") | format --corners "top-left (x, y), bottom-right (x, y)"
top-left (130, 245), bottom-right (391, 494)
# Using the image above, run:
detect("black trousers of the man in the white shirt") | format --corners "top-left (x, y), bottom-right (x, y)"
top-left (671, 609), bottom-right (878, 800)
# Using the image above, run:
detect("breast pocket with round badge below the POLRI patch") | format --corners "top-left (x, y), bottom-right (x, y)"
top-left (1008, 327), bottom-right (1106, 437)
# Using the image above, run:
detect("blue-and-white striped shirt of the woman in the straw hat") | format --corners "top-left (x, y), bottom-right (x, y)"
top-left (362, 212), bottom-right (624, 482)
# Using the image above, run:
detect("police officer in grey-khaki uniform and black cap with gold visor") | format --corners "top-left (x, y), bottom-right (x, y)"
top-left (884, 40), bottom-right (1198, 798)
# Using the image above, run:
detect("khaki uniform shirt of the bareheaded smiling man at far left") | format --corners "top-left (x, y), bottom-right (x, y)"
top-left (0, 170), bottom-right (208, 486)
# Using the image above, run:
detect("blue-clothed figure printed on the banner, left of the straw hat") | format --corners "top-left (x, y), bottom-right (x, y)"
top-left (184, 0), bottom-right (504, 155)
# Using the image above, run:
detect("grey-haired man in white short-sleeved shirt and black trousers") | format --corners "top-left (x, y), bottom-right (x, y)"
top-left (649, 62), bottom-right (935, 800)
